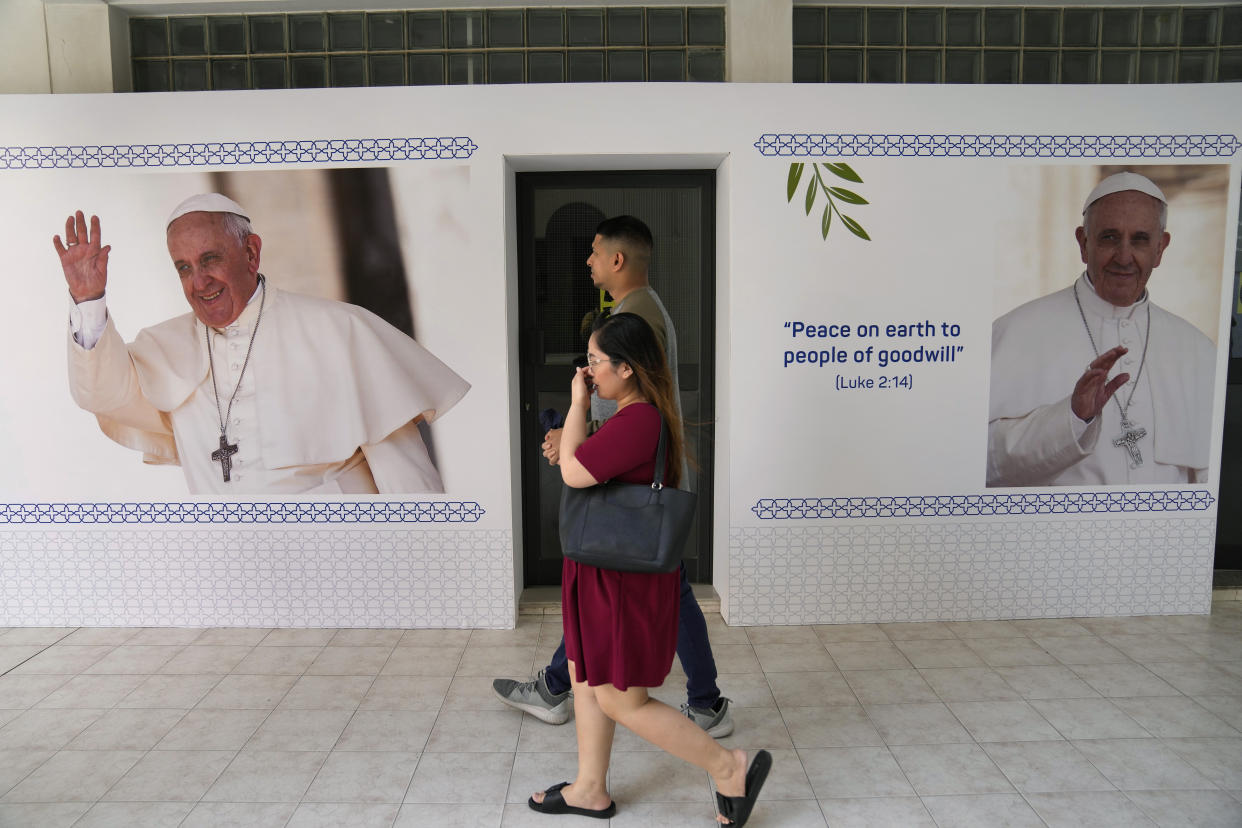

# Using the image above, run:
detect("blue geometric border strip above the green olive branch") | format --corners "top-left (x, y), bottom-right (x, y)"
top-left (755, 133), bottom-right (1242, 158)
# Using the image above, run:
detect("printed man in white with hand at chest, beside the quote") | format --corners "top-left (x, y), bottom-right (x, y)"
top-left (986, 168), bottom-right (1227, 487)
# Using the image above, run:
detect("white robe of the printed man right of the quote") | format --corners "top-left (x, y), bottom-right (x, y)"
top-left (987, 273), bottom-right (1216, 487)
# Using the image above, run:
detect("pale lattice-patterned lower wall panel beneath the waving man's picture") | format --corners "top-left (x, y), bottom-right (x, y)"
top-left (0, 525), bottom-right (517, 628)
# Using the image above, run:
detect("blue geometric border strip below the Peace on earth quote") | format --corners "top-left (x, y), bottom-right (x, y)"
top-left (750, 490), bottom-right (1216, 520)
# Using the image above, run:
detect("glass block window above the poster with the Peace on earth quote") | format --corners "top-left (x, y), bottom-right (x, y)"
top-left (794, 2), bottom-right (1242, 83)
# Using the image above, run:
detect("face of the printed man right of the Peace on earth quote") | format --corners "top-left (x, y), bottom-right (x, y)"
top-left (1076, 190), bottom-right (1169, 308)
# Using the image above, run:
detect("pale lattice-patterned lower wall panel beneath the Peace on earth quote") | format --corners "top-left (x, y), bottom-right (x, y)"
top-left (727, 514), bottom-right (1216, 624)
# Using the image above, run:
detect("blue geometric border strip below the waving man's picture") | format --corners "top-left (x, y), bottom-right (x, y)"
top-left (0, 502), bottom-right (486, 524)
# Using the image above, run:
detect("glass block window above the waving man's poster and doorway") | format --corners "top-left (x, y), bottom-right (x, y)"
top-left (129, 6), bottom-right (725, 92)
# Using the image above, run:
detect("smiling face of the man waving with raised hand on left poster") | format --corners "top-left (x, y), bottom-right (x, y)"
top-left (168, 211), bottom-right (262, 328)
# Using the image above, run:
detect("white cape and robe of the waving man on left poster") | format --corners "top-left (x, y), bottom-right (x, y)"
top-left (68, 284), bottom-right (469, 494)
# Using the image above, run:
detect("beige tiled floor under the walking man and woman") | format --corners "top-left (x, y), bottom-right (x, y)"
top-left (0, 601), bottom-right (1242, 828)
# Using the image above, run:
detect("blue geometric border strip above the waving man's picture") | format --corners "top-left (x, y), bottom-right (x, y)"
top-left (0, 135), bottom-right (478, 170)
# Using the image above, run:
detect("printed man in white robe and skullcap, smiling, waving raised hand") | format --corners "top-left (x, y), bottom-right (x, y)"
top-left (53, 192), bottom-right (469, 495)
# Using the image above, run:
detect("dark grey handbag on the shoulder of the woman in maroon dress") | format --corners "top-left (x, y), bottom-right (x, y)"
top-left (560, 417), bottom-right (698, 572)
